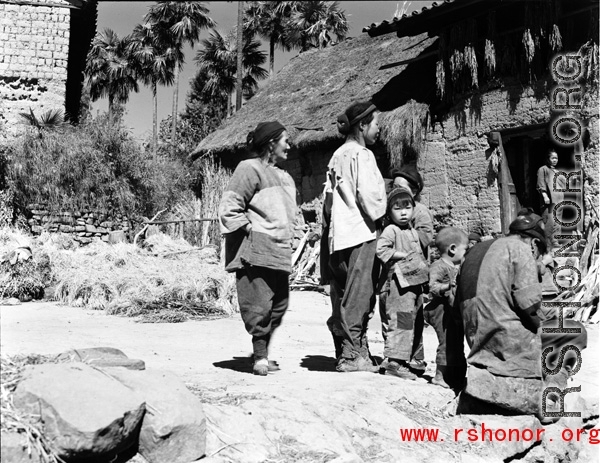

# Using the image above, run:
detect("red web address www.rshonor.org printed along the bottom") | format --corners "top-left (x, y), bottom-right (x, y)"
top-left (400, 423), bottom-right (600, 444)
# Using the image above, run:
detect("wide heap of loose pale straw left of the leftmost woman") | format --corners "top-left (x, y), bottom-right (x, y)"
top-left (51, 235), bottom-right (236, 322)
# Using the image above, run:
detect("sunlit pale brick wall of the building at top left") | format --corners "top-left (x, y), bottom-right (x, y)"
top-left (0, 0), bottom-right (70, 136)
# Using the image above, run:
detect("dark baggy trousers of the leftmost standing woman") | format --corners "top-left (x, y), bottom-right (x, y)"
top-left (235, 266), bottom-right (290, 359)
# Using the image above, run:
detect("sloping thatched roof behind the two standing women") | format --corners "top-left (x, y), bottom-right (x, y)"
top-left (192, 34), bottom-right (435, 205)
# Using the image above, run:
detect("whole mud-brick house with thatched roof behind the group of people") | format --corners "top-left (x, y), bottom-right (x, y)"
top-left (196, 0), bottom-right (600, 239)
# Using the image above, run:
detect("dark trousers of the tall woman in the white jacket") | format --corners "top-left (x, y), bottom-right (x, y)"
top-left (327, 240), bottom-right (379, 359)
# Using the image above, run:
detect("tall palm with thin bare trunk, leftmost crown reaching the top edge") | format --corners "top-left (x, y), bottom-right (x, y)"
top-left (144, 1), bottom-right (216, 143)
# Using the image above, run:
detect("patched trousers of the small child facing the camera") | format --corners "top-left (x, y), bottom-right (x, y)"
top-left (379, 276), bottom-right (424, 362)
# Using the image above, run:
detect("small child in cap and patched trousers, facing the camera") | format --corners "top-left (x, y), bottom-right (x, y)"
top-left (376, 187), bottom-right (428, 380)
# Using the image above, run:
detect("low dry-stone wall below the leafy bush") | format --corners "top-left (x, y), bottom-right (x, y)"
top-left (28, 204), bottom-right (132, 244)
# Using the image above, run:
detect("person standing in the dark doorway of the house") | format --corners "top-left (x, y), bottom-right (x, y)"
top-left (537, 150), bottom-right (566, 249)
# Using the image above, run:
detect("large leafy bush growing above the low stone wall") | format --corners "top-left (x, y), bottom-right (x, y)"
top-left (8, 116), bottom-right (188, 217)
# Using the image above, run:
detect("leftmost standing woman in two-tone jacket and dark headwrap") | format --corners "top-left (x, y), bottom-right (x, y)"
top-left (219, 121), bottom-right (296, 376)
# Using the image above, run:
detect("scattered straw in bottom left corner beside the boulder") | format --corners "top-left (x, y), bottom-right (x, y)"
top-left (0, 355), bottom-right (63, 463)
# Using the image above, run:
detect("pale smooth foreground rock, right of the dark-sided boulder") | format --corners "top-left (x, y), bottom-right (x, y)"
top-left (104, 368), bottom-right (206, 463)
